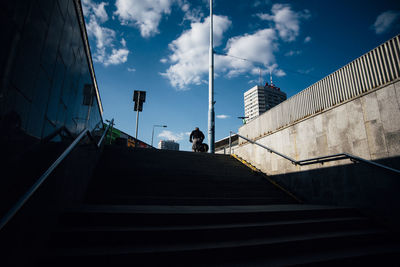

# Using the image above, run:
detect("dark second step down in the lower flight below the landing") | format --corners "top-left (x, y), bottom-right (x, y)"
top-left (51, 217), bottom-right (374, 248)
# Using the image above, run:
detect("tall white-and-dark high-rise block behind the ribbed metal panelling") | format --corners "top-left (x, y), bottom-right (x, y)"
top-left (244, 82), bottom-right (286, 121)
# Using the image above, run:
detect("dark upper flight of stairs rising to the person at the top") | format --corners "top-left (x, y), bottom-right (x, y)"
top-left (87, 146), bottom-right (296, 205)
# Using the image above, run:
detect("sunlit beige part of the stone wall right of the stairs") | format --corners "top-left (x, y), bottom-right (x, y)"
top-left (235, 80), bottom-right (400, 175)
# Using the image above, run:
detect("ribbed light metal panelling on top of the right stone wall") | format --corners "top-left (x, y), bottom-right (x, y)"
top-left (261, 35), bottom-right (400, 130)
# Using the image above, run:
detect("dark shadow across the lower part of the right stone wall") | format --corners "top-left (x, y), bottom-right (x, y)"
top-left (270, 157), bottom-right (400, 231)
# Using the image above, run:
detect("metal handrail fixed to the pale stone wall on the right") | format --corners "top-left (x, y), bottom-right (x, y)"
top-left (229, 131), bottom-right (400, 174)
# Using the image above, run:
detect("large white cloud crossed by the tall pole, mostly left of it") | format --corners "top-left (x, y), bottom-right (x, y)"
top-left (161, 15), bottom-right (231, 90)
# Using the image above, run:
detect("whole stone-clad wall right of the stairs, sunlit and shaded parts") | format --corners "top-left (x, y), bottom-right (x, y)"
top-left (235, 80), bottom-right (400, 228)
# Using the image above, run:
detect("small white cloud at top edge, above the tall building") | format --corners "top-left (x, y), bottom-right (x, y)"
top-left (256, 4), bottom-right (310, 42)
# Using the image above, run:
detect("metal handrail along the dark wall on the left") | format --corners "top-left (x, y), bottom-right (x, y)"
top-left (0, 119), bottom-right (114, 231)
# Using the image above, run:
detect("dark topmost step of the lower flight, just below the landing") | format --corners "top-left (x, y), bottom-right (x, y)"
top-left (60, 204), bottom-right (360, 227)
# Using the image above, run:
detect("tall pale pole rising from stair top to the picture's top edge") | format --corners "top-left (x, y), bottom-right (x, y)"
top-left (208, 0), bottom-right (215, 154)
